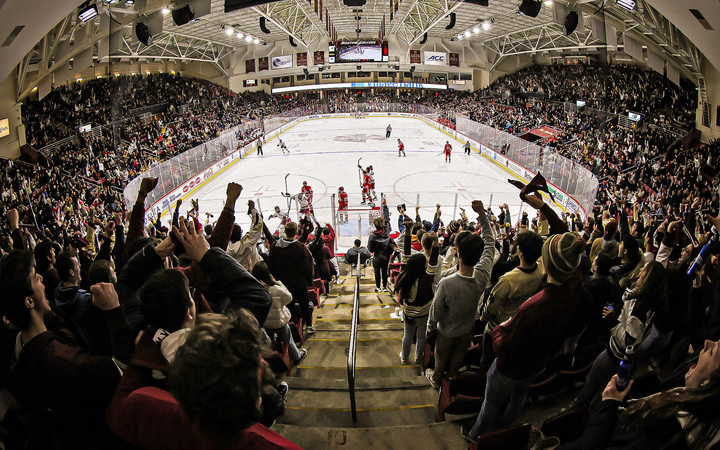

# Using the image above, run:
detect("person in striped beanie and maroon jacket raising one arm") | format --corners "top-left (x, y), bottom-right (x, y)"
top-left (462, 193), bottom-right (585, 442)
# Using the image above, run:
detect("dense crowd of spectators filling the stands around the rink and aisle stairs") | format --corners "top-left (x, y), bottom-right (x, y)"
top-left (0, 67), bottom-right (720, 448)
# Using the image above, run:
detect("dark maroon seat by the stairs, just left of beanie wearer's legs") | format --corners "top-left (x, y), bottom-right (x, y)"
top-left (438, 373), bottom-right (486, 422)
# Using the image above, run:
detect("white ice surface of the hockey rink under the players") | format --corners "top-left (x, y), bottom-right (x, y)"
top-left (177, 116), bottom-right (560, 248)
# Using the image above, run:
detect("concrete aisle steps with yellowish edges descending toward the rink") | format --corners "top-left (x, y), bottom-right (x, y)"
top-left (273, 263), bottom-right (467, 450)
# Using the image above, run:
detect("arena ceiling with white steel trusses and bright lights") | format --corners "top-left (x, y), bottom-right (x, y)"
top-left (0, 0), bottom-right (720, 98)
